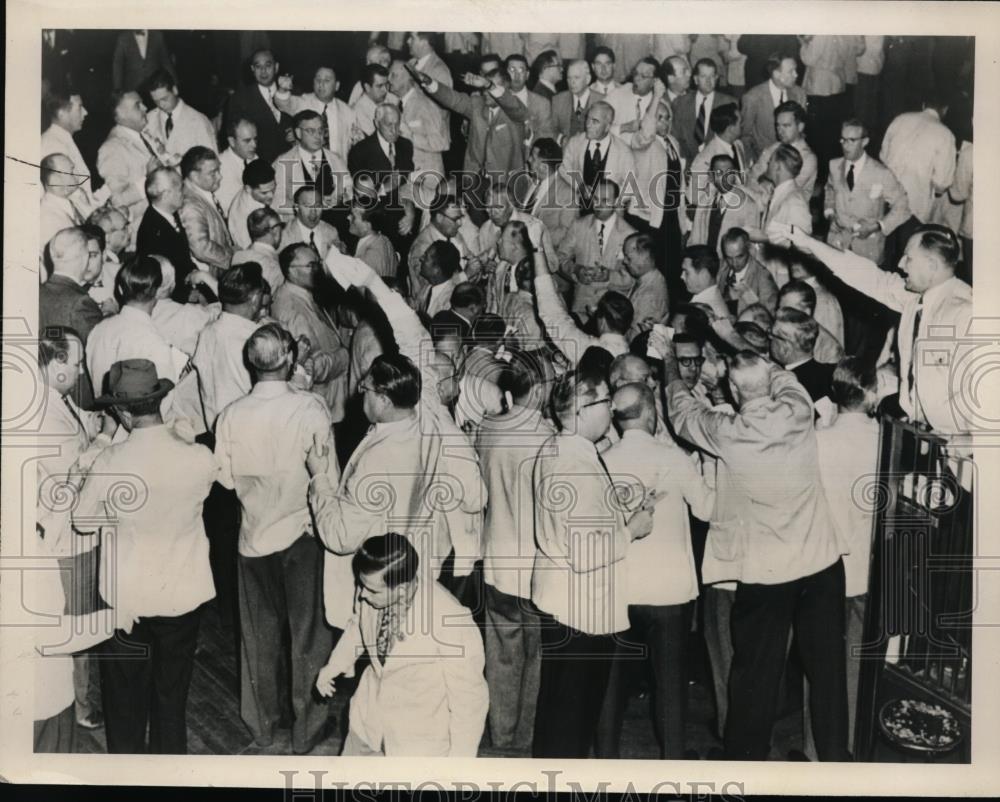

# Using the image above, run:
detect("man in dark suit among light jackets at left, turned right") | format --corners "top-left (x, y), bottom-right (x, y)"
top-left (136, 167), bottom-right (198, 303)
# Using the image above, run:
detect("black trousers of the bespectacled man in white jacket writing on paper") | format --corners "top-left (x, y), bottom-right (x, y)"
top-left (531, 613), bottom-right (616, 759)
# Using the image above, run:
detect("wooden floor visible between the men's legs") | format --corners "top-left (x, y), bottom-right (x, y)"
top-left (76, 601), bottom-right (801, 760)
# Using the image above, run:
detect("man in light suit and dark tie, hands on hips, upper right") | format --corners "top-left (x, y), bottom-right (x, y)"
top-left (823, 119), bottom-right (910, 264)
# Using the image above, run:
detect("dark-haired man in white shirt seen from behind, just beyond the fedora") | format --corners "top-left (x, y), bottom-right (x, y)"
top-left (87, 256), bottom-right (188, 406)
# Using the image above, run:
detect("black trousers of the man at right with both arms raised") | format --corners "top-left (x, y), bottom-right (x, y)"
top-left (725, 559), bottom-right (847, 761)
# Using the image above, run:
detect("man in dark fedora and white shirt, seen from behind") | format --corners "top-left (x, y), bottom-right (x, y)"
top-left (74, 359), bottom-right (219, 754)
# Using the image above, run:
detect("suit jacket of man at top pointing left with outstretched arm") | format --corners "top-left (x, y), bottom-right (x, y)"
top-left (432, 83), bottom-right (529, 173)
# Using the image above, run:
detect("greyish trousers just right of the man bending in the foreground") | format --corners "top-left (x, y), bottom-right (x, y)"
top-left (484, 584), bottom-right (541, 748)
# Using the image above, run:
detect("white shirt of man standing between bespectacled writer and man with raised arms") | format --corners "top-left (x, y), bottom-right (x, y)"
top-left (604, 429), bottom-right (715, 605)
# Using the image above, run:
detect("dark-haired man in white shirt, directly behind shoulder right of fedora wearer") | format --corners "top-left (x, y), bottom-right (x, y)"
top-left (191, 263), bottom-right (265, 431)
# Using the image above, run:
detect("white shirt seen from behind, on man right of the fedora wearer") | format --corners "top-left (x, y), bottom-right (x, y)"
top-left (215, 381), bottom-right (339, 557)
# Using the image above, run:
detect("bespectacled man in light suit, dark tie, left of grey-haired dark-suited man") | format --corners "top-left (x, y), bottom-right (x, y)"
top-left (273, 109), bottom-right (351, 223)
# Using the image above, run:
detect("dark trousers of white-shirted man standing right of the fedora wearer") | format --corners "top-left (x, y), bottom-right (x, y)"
top-left (238, 534), bottom-right (334, 754)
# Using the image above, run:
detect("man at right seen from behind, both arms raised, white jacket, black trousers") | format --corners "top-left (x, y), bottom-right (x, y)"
top-left (650, 332), bottom-right (849, 760)
